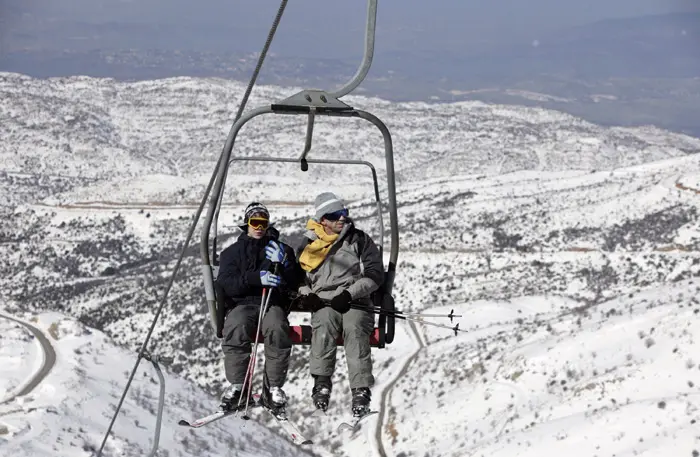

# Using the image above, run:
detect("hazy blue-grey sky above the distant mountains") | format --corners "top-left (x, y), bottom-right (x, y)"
top-left (0, 0), bottom-right (700, 57)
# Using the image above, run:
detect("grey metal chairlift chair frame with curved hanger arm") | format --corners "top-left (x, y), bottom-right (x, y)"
top-left (200, 0), bottom-right (399, 348)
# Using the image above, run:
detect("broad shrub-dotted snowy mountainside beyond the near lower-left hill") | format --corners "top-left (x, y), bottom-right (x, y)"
top-left (0, 74), bottom-right (700, 457)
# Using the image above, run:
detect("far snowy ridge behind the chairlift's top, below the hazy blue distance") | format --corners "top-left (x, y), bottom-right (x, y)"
top-left (0, 73), bottom-right (700, 208)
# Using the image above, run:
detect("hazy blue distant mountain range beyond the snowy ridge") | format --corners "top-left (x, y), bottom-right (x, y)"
top-left (0, 13), bottom-right (700, 136)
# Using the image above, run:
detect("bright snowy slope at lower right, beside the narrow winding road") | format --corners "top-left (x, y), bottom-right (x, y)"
top-left (386, 279), bottom-right (700, 457)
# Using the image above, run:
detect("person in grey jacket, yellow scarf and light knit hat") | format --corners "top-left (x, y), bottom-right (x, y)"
top-left (298, 192), bottom-right (384, 417)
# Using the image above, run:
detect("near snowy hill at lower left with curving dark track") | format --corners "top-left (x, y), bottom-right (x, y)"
top-left (0, 313), bottom-right (308, 457)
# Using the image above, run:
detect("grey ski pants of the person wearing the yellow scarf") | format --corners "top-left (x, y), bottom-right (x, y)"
top-left (309, 306), bottom-right (374, 389)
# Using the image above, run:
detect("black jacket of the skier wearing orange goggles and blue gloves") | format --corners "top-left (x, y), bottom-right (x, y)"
top-left (216, 227), bottom-right (303, 307)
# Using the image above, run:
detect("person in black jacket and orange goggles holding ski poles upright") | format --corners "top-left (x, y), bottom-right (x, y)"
top-left (217, 202), bottom-right (301, 411)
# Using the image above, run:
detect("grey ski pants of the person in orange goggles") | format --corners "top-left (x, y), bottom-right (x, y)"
top-left (221, 305), bottom-right (292, 387)
